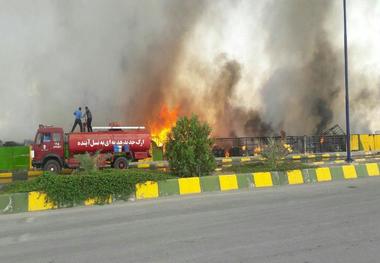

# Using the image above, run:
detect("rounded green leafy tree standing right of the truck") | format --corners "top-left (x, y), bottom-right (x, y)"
top-left (166, 115), bottom-right (216, 177)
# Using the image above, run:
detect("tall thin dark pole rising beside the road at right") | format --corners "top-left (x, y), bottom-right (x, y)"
top-left (343, 0), bottom-right (352, 163)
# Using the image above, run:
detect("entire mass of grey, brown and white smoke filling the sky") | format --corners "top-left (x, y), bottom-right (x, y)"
top-left (0, 0), bottom-right (380, 140)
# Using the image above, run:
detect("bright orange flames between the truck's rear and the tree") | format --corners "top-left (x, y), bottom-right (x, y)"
top-left (149, 105), bottom-right (178, 147)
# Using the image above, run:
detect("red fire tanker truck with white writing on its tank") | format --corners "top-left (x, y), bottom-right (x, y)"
top-left (31, 125), bottom-right (151, 172)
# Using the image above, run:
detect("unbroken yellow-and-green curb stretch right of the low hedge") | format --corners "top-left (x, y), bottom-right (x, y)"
top-left (136, 163), bottom-right (380, 199)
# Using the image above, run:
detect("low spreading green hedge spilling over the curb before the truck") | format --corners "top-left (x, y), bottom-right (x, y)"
top-left (4, 169), bottom-right (173, 207)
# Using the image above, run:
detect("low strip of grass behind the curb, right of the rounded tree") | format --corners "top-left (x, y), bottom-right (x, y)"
top-left (218, 161), bottom-right (316, 174)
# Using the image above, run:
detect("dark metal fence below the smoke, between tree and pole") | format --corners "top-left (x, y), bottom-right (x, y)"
top-left (213, 135), bottom-right (346, 157)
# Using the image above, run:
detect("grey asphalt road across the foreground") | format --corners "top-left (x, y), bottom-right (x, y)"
top-left (0, 178), bottom-right (380, 263)
